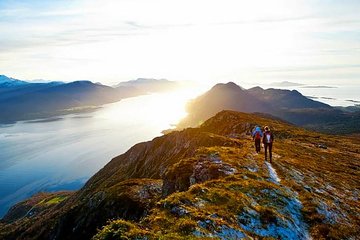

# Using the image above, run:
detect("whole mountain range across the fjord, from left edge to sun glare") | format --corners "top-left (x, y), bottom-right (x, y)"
top-left (0, 75), bottom-right (176, 123)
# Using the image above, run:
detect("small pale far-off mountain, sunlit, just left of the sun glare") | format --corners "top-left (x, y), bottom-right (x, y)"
top-left (114, 78), bottom-right (179, 93)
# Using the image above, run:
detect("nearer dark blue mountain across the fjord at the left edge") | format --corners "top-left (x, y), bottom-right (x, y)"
top-left (0, 81), bottom-right (139, 123)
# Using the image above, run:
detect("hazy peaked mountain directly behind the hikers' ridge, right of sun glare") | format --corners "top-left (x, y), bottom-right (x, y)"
top-left (178, 82), bottom-right (360, 134)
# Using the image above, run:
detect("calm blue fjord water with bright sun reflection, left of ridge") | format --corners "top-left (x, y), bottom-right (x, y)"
top-left (0, 91), bottom-right (195, 216)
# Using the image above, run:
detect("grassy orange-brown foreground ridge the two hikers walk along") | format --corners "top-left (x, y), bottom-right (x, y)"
top-left (0, 111), bottom-right (360, 240)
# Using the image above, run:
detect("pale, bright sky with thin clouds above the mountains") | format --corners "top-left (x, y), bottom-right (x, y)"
top-left (0, 0), bottom-right (360, 85)
